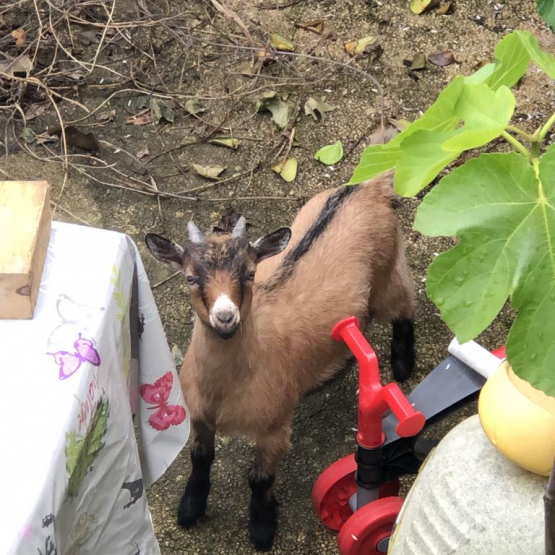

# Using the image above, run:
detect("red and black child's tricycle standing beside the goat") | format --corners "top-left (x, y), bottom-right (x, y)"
top-left (312, 317), bottom-right (503, 555)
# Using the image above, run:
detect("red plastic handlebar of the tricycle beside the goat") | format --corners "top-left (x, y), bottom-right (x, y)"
top-left (331, 316), bottom-right (426, 448)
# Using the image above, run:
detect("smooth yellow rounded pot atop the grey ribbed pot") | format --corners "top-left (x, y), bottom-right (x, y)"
top-left (478, 361), bottom-right (555, 476)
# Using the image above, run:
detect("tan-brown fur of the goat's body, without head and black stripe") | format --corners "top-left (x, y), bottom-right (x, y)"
top-left (185, 175), bottom-right (413, 474)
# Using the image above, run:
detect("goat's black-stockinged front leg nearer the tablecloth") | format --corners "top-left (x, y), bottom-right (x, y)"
top-left (177, 420), bottom-right (216, 528)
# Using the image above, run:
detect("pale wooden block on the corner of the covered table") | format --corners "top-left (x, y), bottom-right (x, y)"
top-left (0, 181), bottom-right (51, 319)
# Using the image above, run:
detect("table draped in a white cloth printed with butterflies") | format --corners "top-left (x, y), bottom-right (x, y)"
top-left (0, 222), bottom-right (190, 555)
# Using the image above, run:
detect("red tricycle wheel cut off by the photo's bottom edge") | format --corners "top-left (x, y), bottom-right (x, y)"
top-left (337, 497), bottom-right (404, 555)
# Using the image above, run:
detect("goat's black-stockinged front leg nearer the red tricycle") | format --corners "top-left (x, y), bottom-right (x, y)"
top-left (249, 419), bottom-right (291, 551)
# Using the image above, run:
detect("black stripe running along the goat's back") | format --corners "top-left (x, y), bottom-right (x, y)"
top-left (261, 185), bottom-right (358, 291)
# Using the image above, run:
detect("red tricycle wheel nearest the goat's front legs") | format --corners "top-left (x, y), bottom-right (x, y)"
top-left (312, 455), bottom-right (399, 530)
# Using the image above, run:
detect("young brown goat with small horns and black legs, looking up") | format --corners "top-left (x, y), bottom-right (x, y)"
top-left (146, 125), bottom-right (415, 551)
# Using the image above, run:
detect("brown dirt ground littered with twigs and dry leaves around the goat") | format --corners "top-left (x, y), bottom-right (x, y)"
top-left (0, 0), bottom-right (555, 555)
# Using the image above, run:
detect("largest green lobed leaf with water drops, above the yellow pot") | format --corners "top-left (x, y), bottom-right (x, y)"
top-left (415, 151), bottom-right (555, 395)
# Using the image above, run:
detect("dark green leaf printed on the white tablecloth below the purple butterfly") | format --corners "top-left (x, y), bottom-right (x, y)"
top-left (65, 399), bottom-right (110, 498)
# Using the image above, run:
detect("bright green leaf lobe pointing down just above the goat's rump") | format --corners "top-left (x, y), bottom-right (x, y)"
top-left (394, 129), bottom-right (463, 197)
